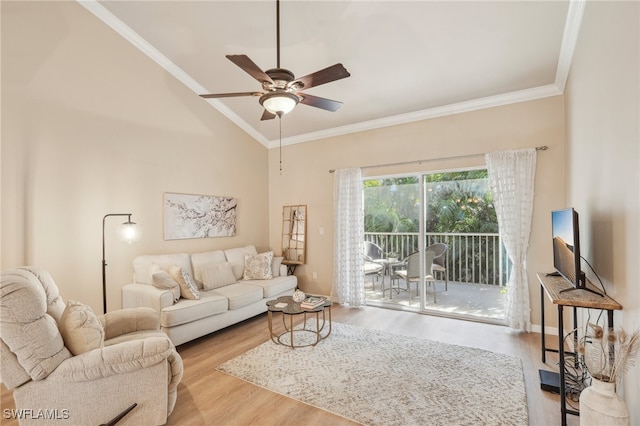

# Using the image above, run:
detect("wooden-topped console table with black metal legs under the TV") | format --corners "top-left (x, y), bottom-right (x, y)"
top-left (537, 272), bottom-right (622, 426)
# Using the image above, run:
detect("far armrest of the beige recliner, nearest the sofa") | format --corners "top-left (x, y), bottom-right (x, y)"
top-left (98, 307), bottom-right (160, 340)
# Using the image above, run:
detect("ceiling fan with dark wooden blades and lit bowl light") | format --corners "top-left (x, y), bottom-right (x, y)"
top-left (200, 0), bottom-right (351, 120)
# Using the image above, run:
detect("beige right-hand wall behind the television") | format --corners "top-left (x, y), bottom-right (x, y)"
top-left (566, 2), bottom-right (640, 424)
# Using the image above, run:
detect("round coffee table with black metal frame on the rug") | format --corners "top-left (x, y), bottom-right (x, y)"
top-left (267, 296), bottom-right (333, 348)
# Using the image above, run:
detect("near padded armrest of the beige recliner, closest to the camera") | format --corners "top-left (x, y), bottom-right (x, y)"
top-left (47, 337), bottom-right (182, 382)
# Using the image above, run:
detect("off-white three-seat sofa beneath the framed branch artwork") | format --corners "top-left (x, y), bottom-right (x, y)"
top-left (122, 246), bottom-right (298, 345)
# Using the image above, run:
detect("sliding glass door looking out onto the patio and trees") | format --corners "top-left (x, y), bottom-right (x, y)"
top-left (364, 170), bottom-right (508, 322)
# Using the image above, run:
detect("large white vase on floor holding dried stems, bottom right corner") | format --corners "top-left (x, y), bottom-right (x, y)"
top-left (580, 378), bottom-right (630, 426)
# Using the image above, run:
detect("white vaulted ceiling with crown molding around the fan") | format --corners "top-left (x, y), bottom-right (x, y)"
top-left (79, 0), bottom-right (583, 146)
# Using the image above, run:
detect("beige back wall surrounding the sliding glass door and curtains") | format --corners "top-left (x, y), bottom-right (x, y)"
top-left (269, 96), bottom-right (565, 325)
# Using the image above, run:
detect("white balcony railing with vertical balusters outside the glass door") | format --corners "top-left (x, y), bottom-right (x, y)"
top-left (365, 232), bottom-right (511, 286)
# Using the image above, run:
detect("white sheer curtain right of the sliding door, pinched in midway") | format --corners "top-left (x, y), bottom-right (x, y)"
top-left (485, 148), bottom-right (536, 331)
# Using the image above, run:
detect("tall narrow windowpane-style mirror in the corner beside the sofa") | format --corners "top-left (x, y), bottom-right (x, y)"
top-left (282, 205), bottom-right (307, 265)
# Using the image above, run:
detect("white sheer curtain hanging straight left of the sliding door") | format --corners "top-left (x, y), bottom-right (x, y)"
top-left (332, 168), bottom-right (365, 306)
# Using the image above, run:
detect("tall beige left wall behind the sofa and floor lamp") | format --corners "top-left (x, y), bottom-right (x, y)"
top-left (1, 1), bottom-right (269, 312)
